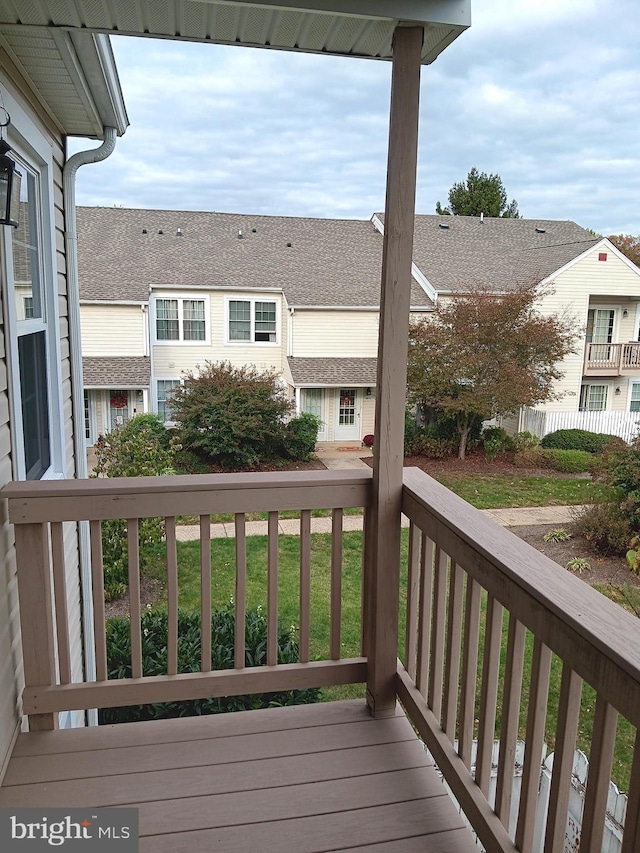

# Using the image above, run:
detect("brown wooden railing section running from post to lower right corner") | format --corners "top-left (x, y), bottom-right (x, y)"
top-left (398, 469), bottom-right (640, 853)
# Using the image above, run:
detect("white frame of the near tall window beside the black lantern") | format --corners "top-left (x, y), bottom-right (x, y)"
top-left (0, 101), bottom-right (66, 480)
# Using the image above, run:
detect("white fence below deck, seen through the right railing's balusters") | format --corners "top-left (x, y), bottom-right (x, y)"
top-left (427, 741), bottom-right (627, 853)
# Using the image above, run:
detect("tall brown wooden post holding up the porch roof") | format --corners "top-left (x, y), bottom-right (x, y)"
top-left (366, 26), bottom-right (424, 716)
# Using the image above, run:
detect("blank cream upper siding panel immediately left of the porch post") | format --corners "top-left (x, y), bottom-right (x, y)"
top-left (291, 308), bottom-right (379, 358)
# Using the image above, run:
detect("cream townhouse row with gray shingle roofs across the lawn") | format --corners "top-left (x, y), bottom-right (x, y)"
top-left (79, 208), bottom-right (640, 443)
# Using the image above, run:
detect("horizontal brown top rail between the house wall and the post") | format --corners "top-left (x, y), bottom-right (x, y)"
top-left (0, 470), bottom-right (372, 524)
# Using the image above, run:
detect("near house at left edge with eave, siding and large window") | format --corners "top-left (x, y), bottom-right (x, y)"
top-left (0, 30), bottom-right (126, 780)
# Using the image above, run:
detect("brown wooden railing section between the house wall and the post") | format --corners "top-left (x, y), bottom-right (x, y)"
top-left (3, 471), bottom-right (371, 730)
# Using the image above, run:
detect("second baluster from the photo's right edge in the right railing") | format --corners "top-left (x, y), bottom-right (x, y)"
top-left (580, 696), bottom-right (616, 853)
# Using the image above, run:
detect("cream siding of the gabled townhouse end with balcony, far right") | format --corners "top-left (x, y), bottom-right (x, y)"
top-left (537, 247), bottom-right (640, 412)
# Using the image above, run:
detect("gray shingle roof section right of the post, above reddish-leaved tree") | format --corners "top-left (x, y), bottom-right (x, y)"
top-left (404, 214), bottom-right (599, 291)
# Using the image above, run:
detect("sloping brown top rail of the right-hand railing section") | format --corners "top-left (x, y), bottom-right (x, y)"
top-left (403, 468), bottom-right (640, 725)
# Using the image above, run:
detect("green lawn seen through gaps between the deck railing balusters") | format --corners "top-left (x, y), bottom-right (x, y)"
top-left (145, 530), bottom-right (640, 790)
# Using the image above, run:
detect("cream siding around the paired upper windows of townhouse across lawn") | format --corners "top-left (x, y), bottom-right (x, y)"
top-left (150, 291), bottom-right (288, 379)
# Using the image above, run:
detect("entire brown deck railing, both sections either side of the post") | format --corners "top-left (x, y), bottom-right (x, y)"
top-left (3, 469), bottom-right (640, 853)
